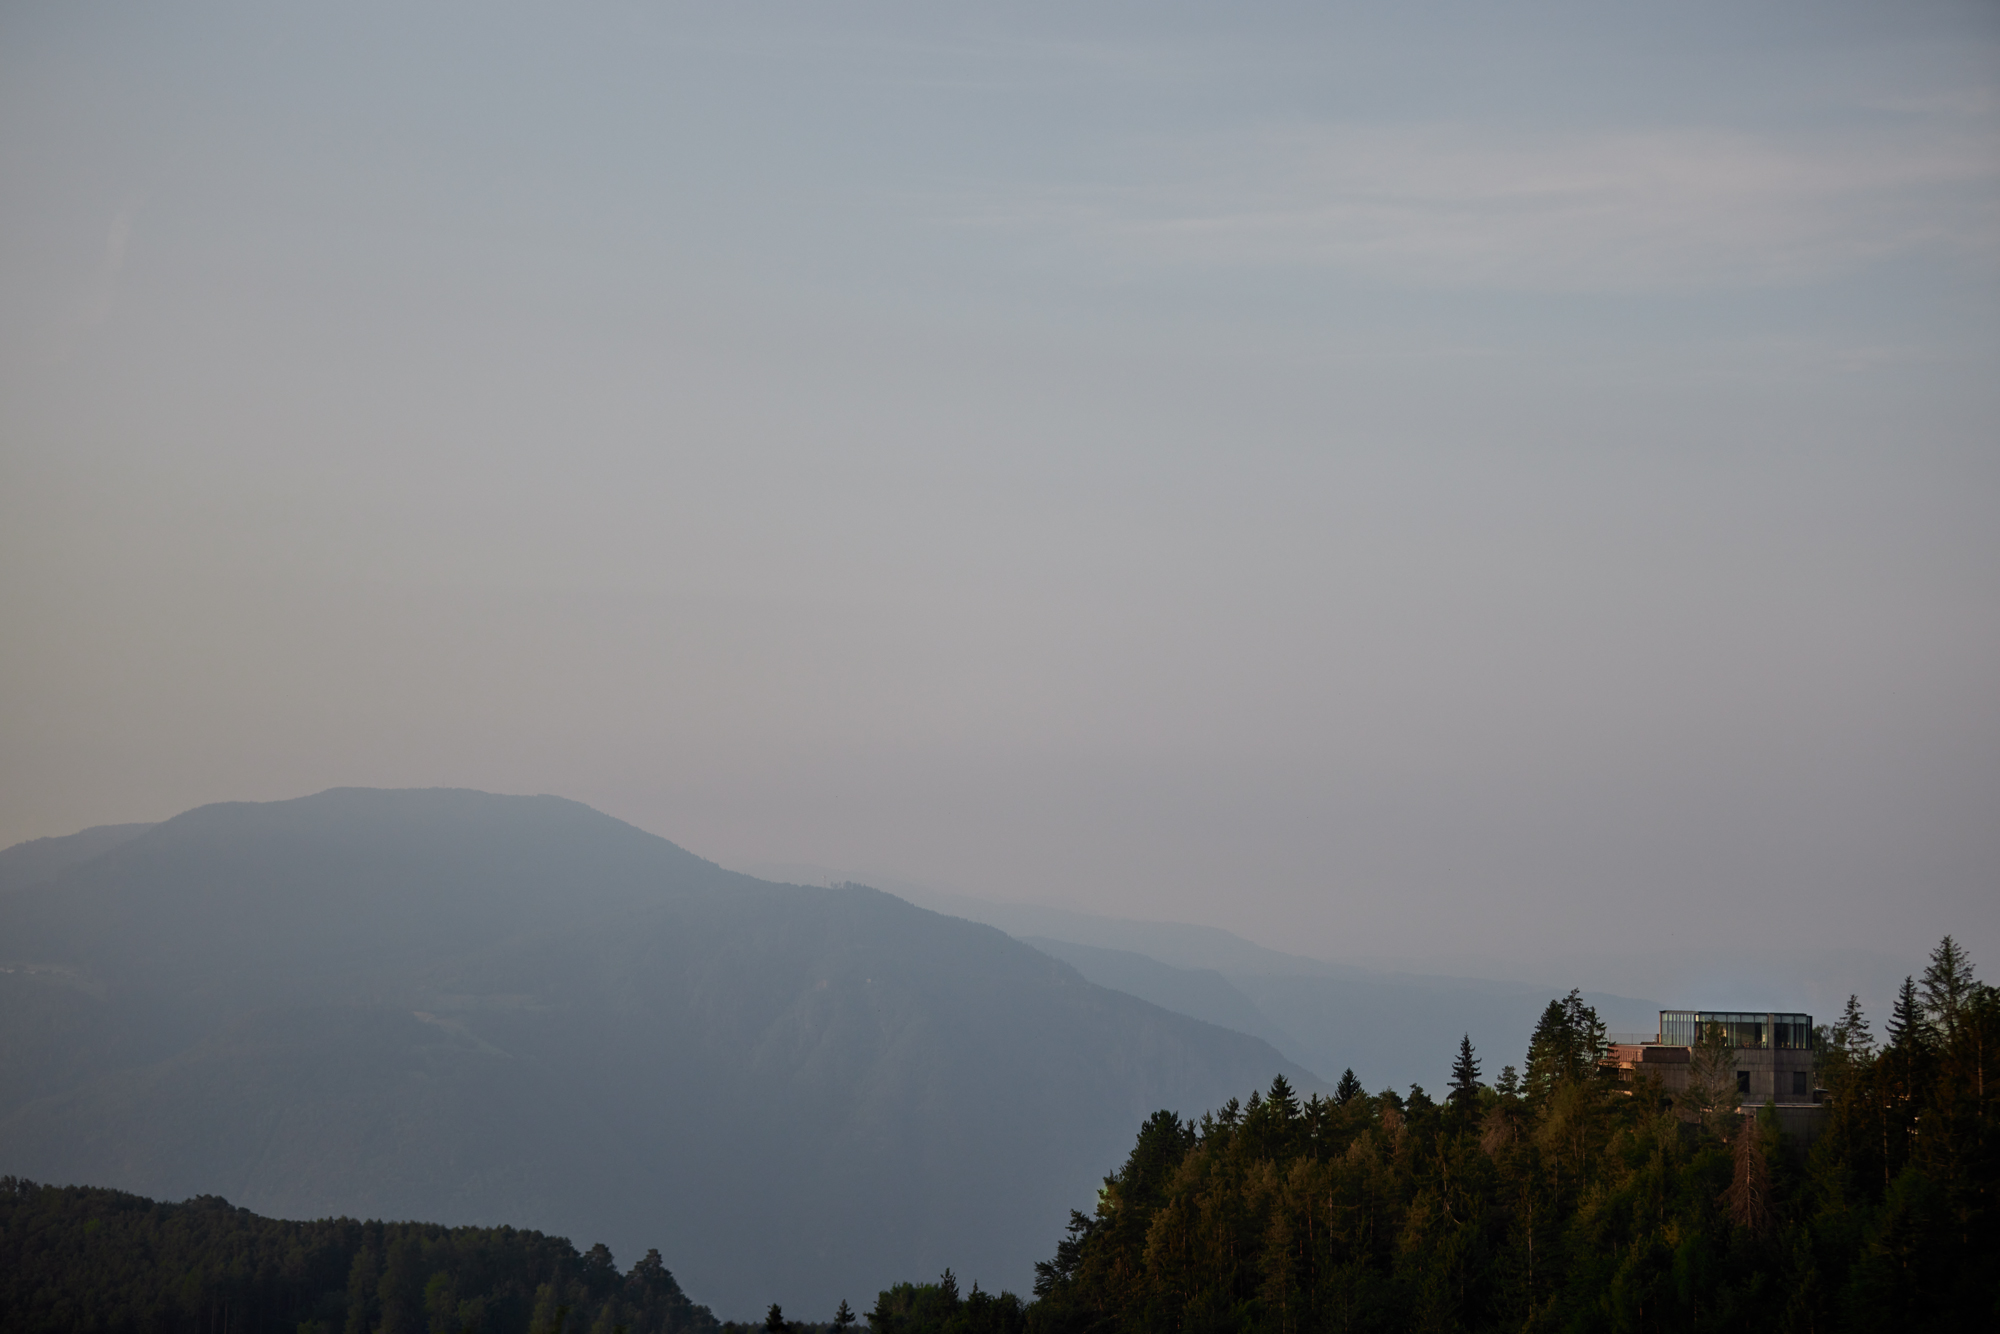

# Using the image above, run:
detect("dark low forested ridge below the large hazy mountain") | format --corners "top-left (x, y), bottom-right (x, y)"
top-left (0, 1176), bottom-right (718, 1334)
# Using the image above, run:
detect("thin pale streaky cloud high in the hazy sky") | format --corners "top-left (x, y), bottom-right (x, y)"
top-left (962, 118), bottom-right (2000, 290)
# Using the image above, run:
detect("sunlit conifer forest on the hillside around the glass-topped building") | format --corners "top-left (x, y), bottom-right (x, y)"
top-left (872, 936), bottom-right (2000, 1334)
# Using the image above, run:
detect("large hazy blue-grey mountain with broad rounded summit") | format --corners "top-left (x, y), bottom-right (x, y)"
top-left (0, 790), bottom-right (1314, 1314)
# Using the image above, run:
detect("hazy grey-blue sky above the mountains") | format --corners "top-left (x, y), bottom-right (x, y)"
top-left (0, 2), bottom-right (2000, 1006)
